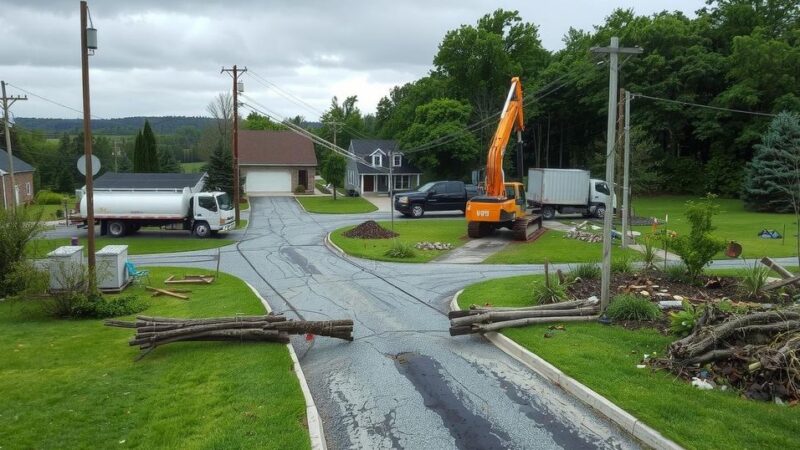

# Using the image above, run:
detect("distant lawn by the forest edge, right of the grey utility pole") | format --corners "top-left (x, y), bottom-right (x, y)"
top-left (633, 196), bottom-right (797, 259)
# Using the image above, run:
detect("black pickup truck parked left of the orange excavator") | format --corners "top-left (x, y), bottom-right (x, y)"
top-left (394, 181), bottom-right (478, 217)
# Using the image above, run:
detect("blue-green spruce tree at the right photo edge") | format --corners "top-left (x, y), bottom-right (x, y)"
top-left (742, 112), bottom-right (800, 212)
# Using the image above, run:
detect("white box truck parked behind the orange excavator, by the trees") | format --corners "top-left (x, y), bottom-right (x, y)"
top-left (526, 169), bottom-right (616, 220)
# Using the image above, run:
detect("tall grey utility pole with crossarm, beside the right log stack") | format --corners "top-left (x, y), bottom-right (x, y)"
top-left (592, 36), bottom-right (642, 312)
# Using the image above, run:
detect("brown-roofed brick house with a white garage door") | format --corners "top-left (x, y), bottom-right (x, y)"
top-left (239, 130), bottom-right (317, 195)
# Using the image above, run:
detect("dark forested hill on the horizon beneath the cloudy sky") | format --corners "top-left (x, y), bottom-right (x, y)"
top-left (15, 116), bottom-right (214, 135)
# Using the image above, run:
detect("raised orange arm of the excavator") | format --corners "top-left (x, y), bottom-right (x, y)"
top-left (486, 77), bottom-right (525, 197)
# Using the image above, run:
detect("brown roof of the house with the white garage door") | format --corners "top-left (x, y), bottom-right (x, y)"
top-left (239, 130), bottom-right (317, 166)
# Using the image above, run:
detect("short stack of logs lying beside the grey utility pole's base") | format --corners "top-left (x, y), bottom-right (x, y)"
top-left (448, 298), bottom-right (600, 336)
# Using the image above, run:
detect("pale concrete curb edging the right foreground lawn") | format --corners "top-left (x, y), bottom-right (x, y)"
top-left (450, 289), bottom-right (683, 450)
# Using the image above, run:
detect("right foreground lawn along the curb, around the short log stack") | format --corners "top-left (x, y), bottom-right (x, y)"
top-left (459, 276), bottom-right (800, 449)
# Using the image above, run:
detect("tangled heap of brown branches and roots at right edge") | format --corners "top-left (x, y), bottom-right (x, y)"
top-left (650, 305), bottom-right (800, 404)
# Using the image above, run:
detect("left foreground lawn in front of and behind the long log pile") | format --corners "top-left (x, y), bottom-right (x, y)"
top-left (0, 268), bottom-right (310, 449)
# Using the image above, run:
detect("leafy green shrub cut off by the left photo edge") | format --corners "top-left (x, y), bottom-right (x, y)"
top-left (0, 208), bottom-right (42, 297)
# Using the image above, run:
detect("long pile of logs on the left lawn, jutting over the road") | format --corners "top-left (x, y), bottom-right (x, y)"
top-left (105, 314), bottom-right (353, 351)
